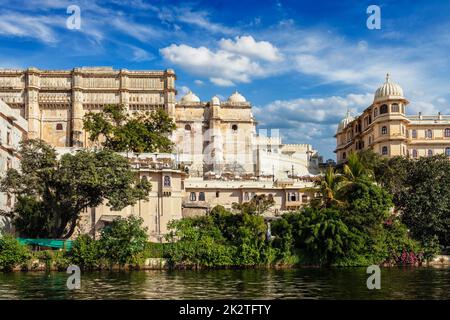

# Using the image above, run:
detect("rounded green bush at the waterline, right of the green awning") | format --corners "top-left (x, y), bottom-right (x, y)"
top-left (98, 216), bottom-right (148, 266)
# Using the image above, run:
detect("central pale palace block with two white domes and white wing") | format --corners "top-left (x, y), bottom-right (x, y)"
top-left (173, 90), bottom-right (317, 179)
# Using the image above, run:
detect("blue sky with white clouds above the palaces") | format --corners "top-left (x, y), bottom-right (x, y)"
top-left (0, 0), bottom-right (450, 158)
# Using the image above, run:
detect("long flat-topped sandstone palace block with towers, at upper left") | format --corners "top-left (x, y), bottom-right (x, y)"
top-left (0, 67), bottom-right (176, 147)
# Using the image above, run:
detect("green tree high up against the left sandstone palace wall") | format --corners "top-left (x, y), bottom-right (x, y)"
top-left (83, 105), bottom-right (176, 153)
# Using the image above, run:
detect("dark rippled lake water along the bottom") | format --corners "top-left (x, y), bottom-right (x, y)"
top-left (0, 268), bottom-right (450, 299)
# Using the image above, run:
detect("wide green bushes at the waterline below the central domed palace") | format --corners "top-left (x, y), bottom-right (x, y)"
top-left (166, 206), bottom-right (271, 267)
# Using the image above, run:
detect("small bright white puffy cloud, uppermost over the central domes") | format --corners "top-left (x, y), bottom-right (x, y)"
top-left (219, 36), bottom-right (281, 61)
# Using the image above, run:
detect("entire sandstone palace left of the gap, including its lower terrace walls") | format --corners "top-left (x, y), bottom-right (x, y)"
top-left (0, 67), bottom-right (320, 241)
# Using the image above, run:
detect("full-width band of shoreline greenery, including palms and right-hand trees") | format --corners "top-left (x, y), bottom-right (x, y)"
top-left (0, 142), bottom-right (450, 271)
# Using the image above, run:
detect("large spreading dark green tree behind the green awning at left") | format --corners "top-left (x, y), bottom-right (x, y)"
top-left (1, 139), bottom-right (151, 238)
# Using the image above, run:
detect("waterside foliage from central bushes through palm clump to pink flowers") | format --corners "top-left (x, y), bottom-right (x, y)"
top-left (165, 154), bottom-right (432, 267)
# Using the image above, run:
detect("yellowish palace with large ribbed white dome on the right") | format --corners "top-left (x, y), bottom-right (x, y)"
top-left (334, 74), bottom-right (450, 165)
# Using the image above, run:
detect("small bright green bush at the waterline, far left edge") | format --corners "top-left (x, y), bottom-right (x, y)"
top-left (0, 235), bottom-right (31, 271)
